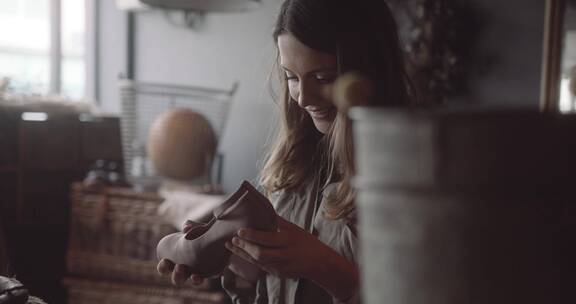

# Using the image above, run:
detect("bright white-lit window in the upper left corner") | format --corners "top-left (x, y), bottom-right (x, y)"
top-left (0, 0), bottom-right (86, 99)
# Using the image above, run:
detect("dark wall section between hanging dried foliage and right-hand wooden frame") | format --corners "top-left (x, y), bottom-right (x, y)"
top-left (455, 0), bottom-right (545, 108)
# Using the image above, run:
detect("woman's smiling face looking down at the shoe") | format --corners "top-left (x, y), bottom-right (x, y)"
top-left (278, 34), bottom-right (338, 134)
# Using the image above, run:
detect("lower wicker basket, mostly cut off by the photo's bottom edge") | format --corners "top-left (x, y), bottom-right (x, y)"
top-left (63, 278), bottom-right (229, 304)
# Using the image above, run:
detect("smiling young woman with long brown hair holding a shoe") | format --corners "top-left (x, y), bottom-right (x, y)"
top-left (159, 0), bottom-right (410, 304)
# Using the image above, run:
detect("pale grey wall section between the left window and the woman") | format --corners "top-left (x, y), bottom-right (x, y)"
top-left (101, 0), bottom-right (280, 191)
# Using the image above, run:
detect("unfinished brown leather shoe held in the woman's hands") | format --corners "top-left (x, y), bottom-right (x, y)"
top-left (156, 181), bottom-right (278, 277)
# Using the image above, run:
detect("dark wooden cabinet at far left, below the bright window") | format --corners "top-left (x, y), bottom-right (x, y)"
top-left (0, 108), bottom-right (122, 303)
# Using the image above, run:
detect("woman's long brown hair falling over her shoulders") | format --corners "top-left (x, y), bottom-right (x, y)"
top-left (260, 0), bottom-right (411, 219)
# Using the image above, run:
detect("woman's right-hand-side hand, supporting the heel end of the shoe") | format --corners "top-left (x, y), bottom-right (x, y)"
top-left (226, 216), bottom-right (337, 278)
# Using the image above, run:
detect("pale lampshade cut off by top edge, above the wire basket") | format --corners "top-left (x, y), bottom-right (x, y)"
top-left (141, 0), bottom-right (261, 12)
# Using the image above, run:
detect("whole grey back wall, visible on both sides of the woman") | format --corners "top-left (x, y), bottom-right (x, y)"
top-left (100, 0), bottom-right (544, 190)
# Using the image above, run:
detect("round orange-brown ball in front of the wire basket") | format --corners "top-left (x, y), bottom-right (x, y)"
top-left (147, 108), bottom-right (217, 181)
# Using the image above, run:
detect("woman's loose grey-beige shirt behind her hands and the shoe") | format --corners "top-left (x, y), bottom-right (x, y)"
top-left (225, 179), bottom-right (360, 304)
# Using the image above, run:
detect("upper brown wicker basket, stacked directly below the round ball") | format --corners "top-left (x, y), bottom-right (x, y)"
top-left (67, 183), bottom-right (194, 285)
